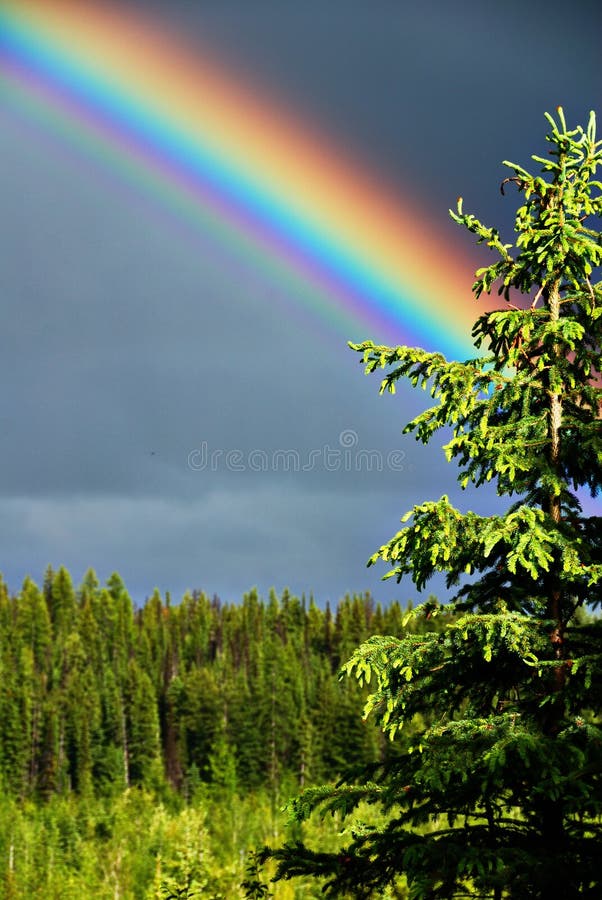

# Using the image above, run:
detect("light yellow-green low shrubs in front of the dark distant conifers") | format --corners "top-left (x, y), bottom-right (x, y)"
top-left (0, 788), bottom-right (356, 900)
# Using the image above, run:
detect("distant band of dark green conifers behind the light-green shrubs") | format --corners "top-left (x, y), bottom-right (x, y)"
top-left (0, 568), bottom-right (446, 800)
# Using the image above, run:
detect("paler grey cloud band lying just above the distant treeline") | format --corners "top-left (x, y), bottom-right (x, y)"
top-left (1, 484), bottom-right (408, 600)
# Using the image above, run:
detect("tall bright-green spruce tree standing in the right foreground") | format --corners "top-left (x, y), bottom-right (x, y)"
top-left (264, 108), bottom-right (602, 900)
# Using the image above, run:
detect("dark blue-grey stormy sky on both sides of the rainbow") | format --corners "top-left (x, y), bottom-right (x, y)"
top-left (0, 0), bottom-right (602, 602)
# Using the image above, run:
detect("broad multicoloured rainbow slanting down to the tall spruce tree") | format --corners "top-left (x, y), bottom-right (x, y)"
top-left (0, 0), bottom-right (478, 358)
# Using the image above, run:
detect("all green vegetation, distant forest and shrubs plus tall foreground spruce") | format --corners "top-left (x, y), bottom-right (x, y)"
top-left (0, 107), bottom-right (602, 900)
